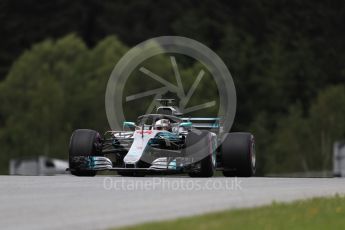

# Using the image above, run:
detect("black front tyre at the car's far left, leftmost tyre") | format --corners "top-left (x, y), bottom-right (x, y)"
top-left (69, 129), bottom-right (101, 177)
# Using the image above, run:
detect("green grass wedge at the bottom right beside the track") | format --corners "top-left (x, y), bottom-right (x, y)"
top-left (115, 196), bottom-right (345, 230)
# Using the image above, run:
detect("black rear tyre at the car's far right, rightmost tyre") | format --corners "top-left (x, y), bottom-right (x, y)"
top-left (221, 133), bottom-right (256, 177)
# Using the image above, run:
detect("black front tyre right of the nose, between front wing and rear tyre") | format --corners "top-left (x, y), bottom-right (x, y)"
top-left (186, 130), bottom-right (215, 177)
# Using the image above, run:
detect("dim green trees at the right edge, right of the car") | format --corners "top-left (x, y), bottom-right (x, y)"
top-left (263, 86), bottom-right (345, 173)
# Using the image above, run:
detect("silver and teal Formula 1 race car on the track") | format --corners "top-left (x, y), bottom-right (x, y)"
top-left (69, 99), bottom-right (255, 177)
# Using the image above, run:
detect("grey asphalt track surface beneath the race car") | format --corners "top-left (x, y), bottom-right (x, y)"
top-left (0, 176), bottom-right (345, 230)
